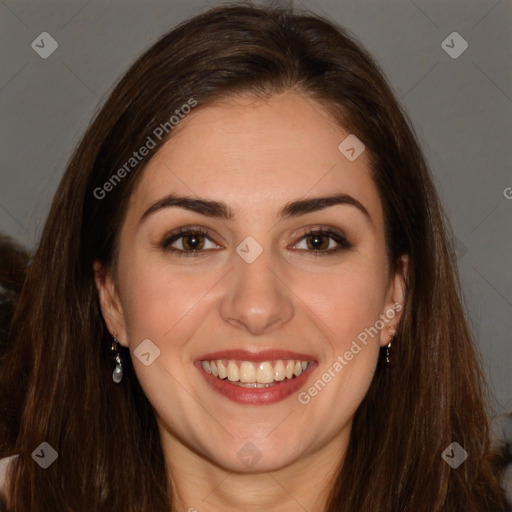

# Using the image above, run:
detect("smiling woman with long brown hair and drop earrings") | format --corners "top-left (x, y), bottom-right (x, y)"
top-left (0, 4), bottom-right (509, 512)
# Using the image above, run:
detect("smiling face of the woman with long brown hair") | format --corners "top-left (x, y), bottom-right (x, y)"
top-left (96, 92), bottom-right (404, 472)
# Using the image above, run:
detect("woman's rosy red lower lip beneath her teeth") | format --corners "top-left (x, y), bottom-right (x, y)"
top-left (195, 361), bottom-right (317, 405)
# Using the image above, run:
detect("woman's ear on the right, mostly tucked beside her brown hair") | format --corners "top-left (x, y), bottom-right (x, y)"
top-left (380, 254), bottom-right (409, 347)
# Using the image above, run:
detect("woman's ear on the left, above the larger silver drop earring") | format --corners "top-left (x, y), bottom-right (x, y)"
top-left (93, 260), bottom-right (128, 347)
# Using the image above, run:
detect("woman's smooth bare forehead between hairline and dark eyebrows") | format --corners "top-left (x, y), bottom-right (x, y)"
top-left (125, 92), bottom-right (382, 226)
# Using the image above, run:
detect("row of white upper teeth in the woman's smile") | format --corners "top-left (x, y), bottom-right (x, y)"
top-left (202, 359), bottom-right (309, 384)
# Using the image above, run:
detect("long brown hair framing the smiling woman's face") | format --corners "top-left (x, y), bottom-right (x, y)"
top-left (0, 2), bottom-right (507, 512)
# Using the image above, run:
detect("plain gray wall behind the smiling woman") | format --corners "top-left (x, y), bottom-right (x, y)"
top-left (0, 0), bottom-right (512, 413)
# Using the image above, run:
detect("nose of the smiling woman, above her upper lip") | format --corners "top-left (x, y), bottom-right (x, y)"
top-left (221, 250), bottom-right (294, 336)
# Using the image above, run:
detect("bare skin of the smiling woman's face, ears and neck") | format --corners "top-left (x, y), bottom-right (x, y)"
top-left (95, 91), bottom-right (407, 512)
